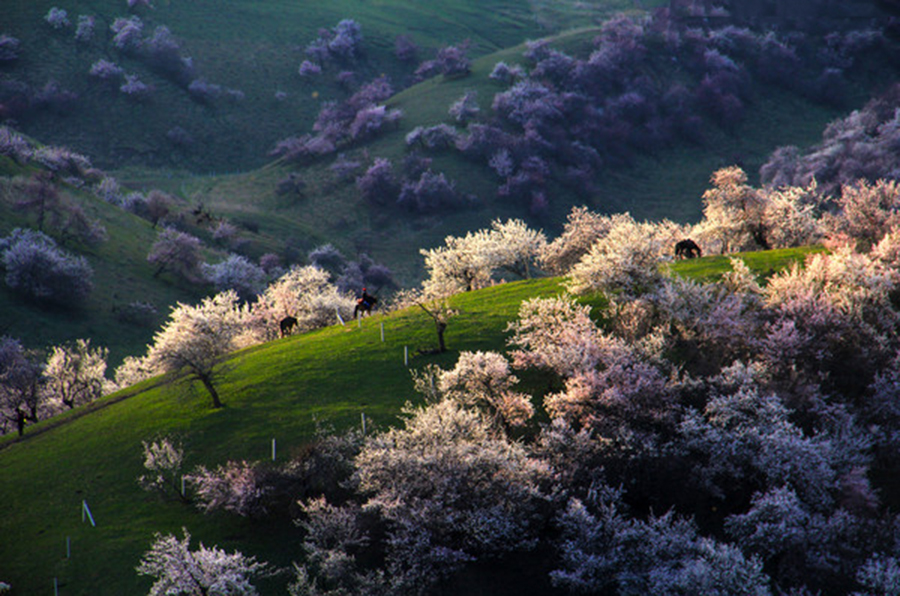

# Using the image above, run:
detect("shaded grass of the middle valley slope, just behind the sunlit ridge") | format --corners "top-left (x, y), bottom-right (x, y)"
top-left (178, 28), bottom-right (869, 285)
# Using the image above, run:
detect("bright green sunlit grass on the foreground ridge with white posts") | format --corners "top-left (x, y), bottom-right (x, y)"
top-left (0, 249), bottom-right (808, 596)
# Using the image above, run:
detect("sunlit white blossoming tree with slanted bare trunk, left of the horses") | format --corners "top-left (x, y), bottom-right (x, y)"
top-left (147, 290), bottom-right (246, 408)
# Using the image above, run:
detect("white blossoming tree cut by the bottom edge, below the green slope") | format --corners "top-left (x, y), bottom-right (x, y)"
top-left (136, 528), bottom-right (271, 596)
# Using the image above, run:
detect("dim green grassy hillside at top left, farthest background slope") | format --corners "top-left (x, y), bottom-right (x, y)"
top-left (0, 0), bottom-right (664, 172)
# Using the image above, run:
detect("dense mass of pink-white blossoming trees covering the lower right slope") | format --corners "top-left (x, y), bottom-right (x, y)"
top-left (119, 168), bottom-right (900, 596)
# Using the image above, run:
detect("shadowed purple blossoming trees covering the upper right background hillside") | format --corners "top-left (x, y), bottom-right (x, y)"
top-left (306, 10), bottom-right (897, 219)
